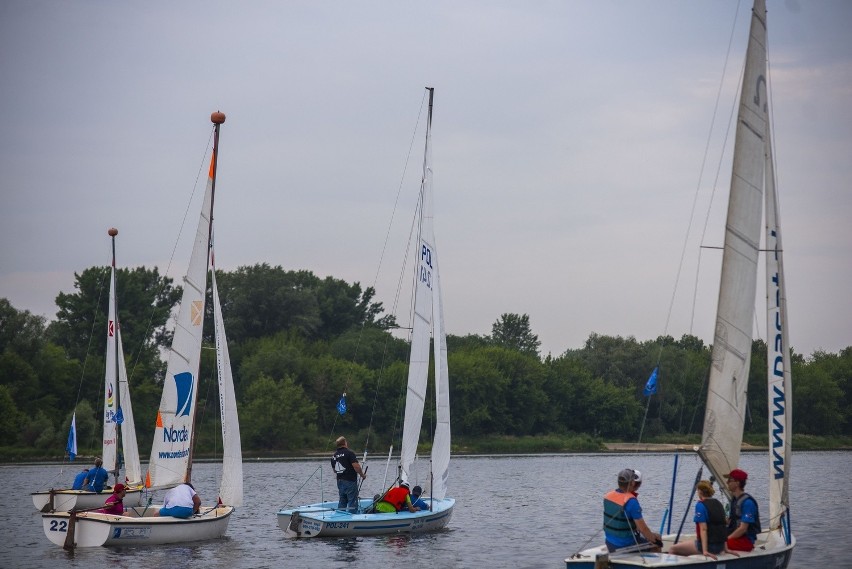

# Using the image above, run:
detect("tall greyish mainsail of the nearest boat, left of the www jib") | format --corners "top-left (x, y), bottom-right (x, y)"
top-left (699, 0), bottom-right (768, 488)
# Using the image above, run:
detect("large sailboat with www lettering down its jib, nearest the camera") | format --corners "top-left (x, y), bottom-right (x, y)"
top-left (565, 0), bottom-right (796, 569)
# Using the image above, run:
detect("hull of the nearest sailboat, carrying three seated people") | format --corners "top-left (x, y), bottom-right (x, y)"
top-left (565, 530), bottom-right (796, 569)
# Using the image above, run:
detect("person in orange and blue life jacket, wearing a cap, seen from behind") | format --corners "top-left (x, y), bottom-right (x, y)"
top-left (603, 468), bottom-right (663, 551)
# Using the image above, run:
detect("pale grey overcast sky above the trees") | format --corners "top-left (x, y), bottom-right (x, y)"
top-left (0, 0), bottom-right (852, 356)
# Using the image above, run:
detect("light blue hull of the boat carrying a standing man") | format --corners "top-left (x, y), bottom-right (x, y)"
top-left (278, 498), bottom-right (455, 538)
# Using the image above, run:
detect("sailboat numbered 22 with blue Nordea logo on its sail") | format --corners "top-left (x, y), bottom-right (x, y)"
top-left (42, 112), bottom-right (243, 549)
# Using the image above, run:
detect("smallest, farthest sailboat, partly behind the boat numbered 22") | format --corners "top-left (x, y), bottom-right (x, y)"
top-left (32, 228), bottom-right (143, 512)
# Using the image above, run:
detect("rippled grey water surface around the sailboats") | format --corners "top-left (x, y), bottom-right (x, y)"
top-left (0, 452), bottom-right (852, 569)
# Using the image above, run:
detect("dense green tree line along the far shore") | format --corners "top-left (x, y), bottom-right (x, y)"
top-left (0, 264), bottom-right (852, 458)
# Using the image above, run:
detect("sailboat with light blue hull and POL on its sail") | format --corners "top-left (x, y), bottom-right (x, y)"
top-left (278, 87), bottom-right (455, 538)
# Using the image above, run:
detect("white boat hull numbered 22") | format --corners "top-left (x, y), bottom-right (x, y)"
top-left (42, 506), bottom-right (234, 547)
